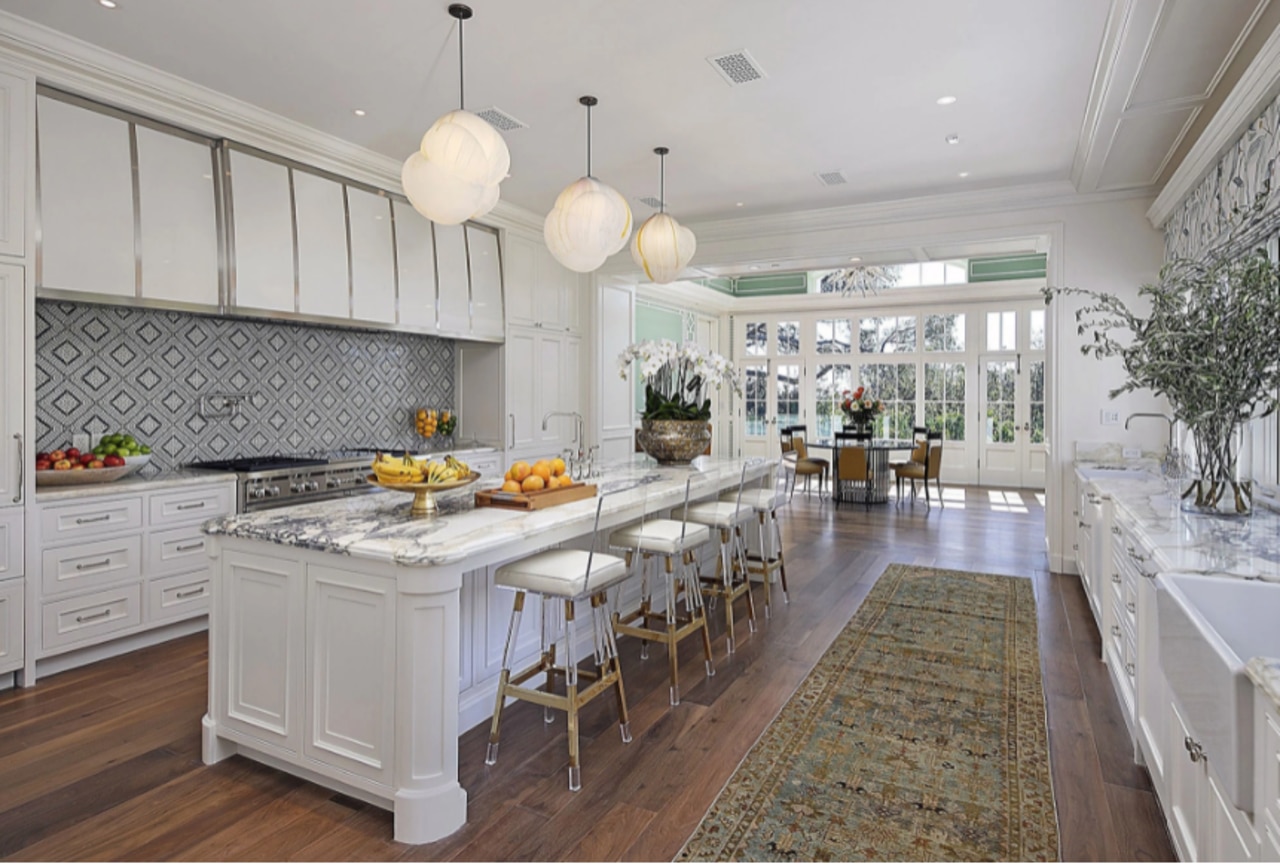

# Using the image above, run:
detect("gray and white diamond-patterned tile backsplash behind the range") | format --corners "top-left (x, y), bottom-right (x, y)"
top-left (36, 301), bottom-right (454, 466)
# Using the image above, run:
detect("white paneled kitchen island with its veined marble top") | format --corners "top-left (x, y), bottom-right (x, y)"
top-left (204, 457), bottom-right (765, 843)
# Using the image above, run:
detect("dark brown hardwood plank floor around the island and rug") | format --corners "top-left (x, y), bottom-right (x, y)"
top-left (0, 488), bottom-right (1174, 862)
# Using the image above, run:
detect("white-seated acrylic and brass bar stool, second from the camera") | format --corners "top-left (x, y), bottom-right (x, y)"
top-left (609, 473), bottom-right (716, 706)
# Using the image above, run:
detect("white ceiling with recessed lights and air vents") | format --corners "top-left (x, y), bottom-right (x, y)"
top-left (0, 0), bottom-right (1265, 230)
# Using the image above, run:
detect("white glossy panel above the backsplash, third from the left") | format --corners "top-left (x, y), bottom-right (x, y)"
top-left (231, 150), bottom-right (297, 312)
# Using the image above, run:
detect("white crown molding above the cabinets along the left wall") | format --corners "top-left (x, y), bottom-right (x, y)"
top-left (0, 12), bottom-right (543, 231)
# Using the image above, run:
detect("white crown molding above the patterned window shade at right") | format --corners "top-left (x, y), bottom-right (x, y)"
top-left (1147, 12), bottom-right (1280, 229)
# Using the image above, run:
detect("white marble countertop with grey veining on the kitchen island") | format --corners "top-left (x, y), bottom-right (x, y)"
top-left (205, 457), bottom-right (764, 566)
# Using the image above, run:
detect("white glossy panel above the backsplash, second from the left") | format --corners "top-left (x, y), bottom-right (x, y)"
top-left (137, 127), bottom-right (218, 307)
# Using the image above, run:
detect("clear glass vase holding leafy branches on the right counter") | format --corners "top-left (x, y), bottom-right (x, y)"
top-left (1181, 420), bottom-right (1253, 517)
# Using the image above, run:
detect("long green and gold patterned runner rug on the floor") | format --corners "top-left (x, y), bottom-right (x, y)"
top-left (677, 565), bottom-right (1059, 861)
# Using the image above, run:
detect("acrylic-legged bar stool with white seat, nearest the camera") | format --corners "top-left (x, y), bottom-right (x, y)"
top-left (485, 496), bottom-right (631, 791)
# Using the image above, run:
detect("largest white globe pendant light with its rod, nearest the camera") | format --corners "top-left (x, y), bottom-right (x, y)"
top-left (401, 3), bottom-right (511, 225)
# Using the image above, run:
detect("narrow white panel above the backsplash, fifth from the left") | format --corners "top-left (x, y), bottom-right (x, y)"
top-left (347, 187), bottom-right (396, 324)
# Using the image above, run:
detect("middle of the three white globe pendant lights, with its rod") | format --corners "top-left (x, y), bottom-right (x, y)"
top-left (543, 96), bottom-right (631, 274)
